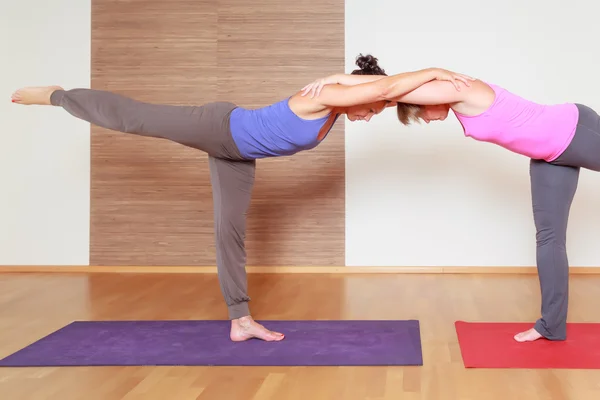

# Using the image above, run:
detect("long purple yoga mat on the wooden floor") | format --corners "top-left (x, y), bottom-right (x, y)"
top-left (0, 320), bottom-right (423, 367)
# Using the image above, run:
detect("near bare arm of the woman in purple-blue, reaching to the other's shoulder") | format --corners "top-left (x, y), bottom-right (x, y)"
top-left (317, 68), bottom-right (473, 107)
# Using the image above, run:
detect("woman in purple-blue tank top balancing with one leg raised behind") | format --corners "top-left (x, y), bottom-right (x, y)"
top-left (7, 57), bottom-right (466, 341)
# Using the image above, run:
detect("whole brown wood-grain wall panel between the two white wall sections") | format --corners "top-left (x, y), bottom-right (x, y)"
top-left (90, 0), bottom-right (344, 266)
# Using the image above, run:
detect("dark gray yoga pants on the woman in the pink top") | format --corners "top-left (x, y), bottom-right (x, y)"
top-left (530, 104), bottom-right (600, 340)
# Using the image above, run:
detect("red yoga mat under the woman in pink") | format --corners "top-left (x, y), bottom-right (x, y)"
top-left (455, 321), bottom-right (600, 369)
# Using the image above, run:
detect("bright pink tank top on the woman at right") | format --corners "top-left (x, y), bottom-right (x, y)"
top-left (454, 84), bottom-right (579, 161)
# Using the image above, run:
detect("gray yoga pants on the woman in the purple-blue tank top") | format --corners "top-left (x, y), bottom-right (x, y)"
top-left (50, 89), bottom-right (256, 319)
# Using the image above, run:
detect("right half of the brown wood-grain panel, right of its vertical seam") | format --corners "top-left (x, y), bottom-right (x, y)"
top-left (217, 0), bottom-right (345, 266)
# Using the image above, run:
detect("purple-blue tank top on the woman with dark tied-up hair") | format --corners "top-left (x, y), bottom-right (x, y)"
top-left (230, 98), bottom-right (339, 159)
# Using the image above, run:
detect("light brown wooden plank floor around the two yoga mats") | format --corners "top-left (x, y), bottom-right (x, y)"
top-left (0, 274), bottom-right (600, 400)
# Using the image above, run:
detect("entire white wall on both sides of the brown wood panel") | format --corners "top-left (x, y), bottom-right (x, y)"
top-left (0, 0), bottom-right (600, 266)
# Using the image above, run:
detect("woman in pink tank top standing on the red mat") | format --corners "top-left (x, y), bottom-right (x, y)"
top-left (306, 59), bottom-right (600, 342)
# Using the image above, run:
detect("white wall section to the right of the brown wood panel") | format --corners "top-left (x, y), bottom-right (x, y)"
top-left (346, 0), bottom-right (600, 266)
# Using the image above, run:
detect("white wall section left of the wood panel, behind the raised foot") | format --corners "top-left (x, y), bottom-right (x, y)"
top-left (0, 0), bottom-right (91, 265)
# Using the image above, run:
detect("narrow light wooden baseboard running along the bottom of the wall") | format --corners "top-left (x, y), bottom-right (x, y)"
top-left (0, 265), bottom-right (600, 274)
